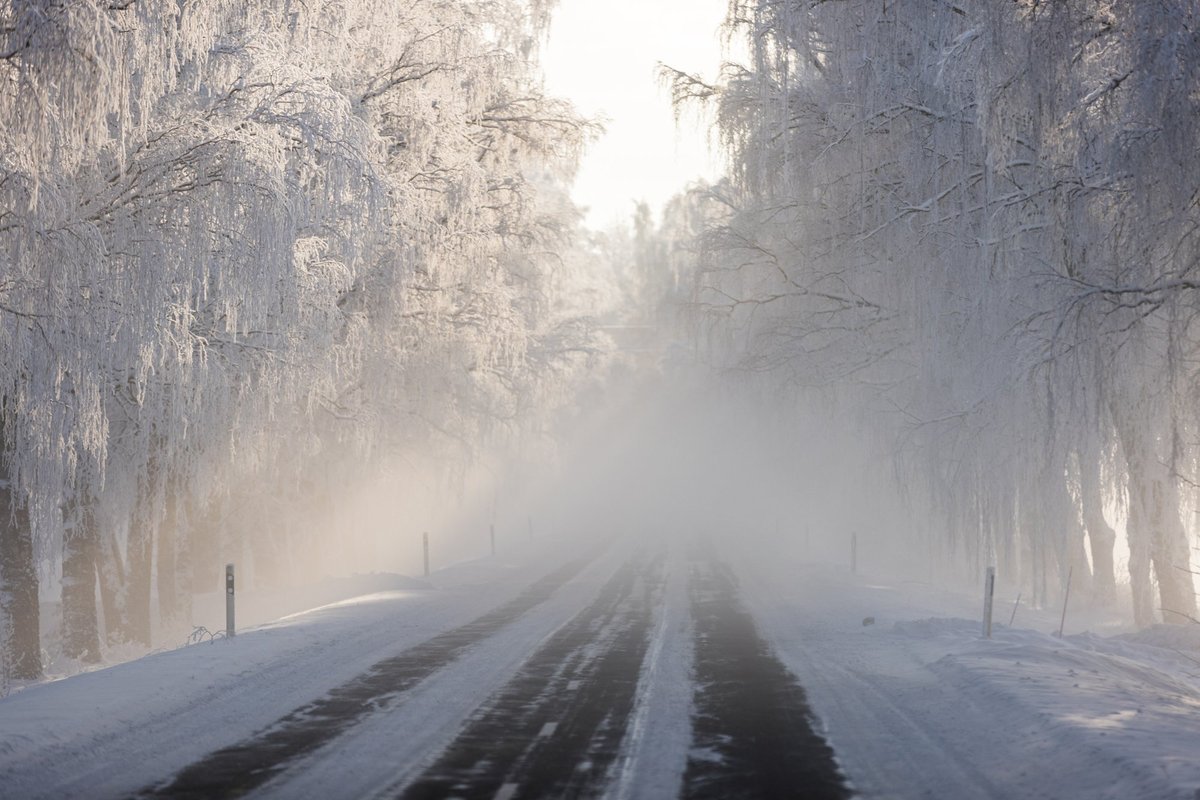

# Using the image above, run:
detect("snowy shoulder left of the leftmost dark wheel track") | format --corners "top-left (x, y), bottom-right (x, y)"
top-left (0, 537), bottom-right (609, 798)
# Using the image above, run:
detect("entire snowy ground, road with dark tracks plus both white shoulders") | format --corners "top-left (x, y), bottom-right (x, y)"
top-left (0, 532), bottom-right (1200, 800)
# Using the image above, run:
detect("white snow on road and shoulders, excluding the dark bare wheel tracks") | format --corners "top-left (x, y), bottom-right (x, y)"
top-left (0, 532), bottom-right (1200, 800)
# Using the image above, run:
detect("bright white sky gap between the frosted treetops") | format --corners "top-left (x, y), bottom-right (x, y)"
top-left (542, 0), bottom-right (727, 228)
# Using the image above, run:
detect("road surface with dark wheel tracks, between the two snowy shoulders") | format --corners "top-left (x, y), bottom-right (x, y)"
top-left (138, 551), bottom-right (848, 800)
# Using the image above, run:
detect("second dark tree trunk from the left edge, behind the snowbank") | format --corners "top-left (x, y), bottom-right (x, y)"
top-left (62, 505), bottom-right (101, 663)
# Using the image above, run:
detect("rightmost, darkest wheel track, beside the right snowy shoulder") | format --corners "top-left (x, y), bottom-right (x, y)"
top-left (682, 559), bottom-right (851, 800)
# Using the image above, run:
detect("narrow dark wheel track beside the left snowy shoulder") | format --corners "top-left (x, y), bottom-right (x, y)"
top-left (136, 553), bottom-right (598, 800)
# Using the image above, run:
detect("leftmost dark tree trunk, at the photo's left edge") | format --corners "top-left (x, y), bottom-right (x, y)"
top-left (0, 475), bottom-right (42, 680)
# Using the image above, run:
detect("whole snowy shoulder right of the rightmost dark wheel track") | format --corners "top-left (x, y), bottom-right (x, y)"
top-left (724, 546), bottom-right (1200, 800)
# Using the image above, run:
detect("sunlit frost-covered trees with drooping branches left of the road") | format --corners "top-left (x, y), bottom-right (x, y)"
top-left (0, 0), bottom-right (600, 678)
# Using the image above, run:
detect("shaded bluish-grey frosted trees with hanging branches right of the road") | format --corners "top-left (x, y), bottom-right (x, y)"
top-left (672, 0), bottom-right (1200, 624)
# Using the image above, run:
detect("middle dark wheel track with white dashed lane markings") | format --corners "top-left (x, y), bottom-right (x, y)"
top-left (397, 559), bottom-right (664, 800)
